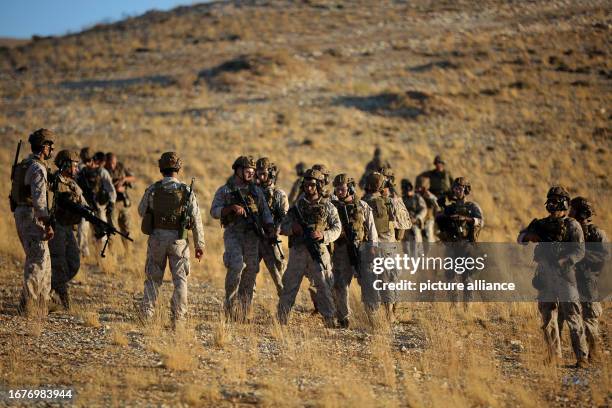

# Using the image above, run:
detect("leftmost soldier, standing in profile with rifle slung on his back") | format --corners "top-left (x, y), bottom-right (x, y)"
top-left (10, 129), bottom-right (55, 314)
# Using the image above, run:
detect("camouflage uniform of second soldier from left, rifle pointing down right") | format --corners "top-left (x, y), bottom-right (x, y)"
top-left (49, 164), bottom-right (87, 308)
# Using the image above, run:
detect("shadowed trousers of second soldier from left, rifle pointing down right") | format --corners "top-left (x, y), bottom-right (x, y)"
top-left (49, 224), bottom-right (81, 294)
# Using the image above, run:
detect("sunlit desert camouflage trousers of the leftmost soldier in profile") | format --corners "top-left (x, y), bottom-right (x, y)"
top-left (14, 206), bottom-right (51, 303)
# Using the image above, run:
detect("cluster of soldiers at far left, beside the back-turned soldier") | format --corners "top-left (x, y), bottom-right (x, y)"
top-left (10, 129), bottom-right (135, 312)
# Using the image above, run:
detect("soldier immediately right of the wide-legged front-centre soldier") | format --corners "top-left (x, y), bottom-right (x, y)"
top-left (332, 174), bottom-right (378, 328)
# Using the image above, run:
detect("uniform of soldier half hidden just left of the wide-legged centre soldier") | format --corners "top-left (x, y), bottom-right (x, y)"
top-left (259, 185), bottom-right (289, 296)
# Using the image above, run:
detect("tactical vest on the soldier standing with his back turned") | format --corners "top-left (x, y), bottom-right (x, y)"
top-left (152, 181), bottom-right (187, 231)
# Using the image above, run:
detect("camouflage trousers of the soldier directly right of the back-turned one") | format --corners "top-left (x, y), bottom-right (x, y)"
top-left (223, 227), bottom-right (260, 319)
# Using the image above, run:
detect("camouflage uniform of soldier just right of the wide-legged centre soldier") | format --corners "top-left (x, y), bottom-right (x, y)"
top-left (332, 196), bottom-right (378, 325)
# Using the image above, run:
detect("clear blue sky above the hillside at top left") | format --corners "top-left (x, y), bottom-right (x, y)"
top-left (0, 0), bottom-right (195, 38)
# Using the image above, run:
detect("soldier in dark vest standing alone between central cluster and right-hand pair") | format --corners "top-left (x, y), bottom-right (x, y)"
top-left (436, 177), bottom-right (484, 302)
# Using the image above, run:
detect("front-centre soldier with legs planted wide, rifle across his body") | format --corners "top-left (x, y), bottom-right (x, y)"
top-left (278, 169), bottom-right (342, 327)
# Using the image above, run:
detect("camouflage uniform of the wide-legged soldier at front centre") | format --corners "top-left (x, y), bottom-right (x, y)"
top-left (278, 194), bottom-right (342, 325)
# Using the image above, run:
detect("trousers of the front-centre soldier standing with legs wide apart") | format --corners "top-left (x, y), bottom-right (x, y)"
top-left (278, 244), bottom-right (336, 324)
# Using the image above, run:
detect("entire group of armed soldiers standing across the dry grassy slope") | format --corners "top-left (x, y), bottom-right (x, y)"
top-left (11, 129), bottom-right (607, 365)
